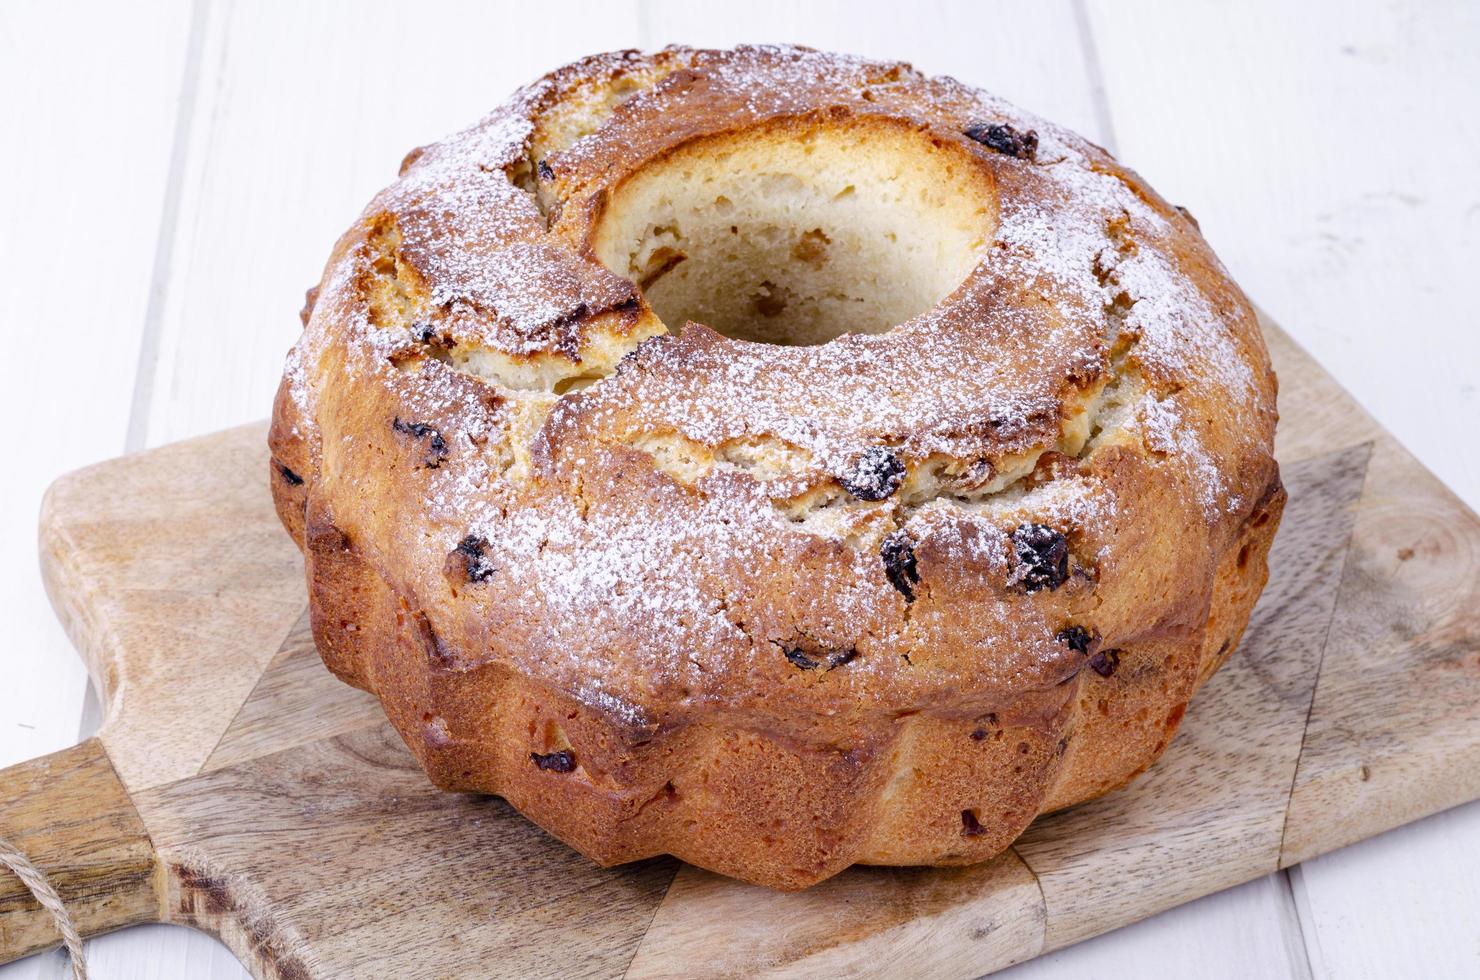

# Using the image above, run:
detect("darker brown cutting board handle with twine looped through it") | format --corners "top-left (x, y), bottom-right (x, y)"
top-left (0, 739), bottom-right (163, 962)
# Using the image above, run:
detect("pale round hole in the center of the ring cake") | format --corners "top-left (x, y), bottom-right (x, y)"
top-left (592, 118), bottom-right (996, 345)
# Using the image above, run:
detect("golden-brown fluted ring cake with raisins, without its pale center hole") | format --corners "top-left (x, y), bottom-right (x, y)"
top-left (271, 47), bottom-right (1283, 888)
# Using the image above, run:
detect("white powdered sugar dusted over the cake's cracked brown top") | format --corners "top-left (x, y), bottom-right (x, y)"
top-left (287, 47), bottom-right (1271, 724)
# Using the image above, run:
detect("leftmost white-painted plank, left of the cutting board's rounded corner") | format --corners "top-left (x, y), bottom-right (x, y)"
top-left (0, 0), bottom-right (189, 980)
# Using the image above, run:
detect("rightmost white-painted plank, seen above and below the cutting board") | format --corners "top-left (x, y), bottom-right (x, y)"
top-left (1089, 1), bottom-right (1480, 979)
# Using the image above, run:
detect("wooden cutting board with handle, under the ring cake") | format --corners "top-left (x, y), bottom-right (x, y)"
top-left (0, 316), bottom-right (1480, 977)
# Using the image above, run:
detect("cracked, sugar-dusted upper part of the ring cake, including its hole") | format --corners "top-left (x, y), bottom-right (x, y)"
top-left (272, 47), bottom-right (1277, 740)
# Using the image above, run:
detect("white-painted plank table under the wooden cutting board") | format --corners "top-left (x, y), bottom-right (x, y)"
top-left (0, 0), bottom-right (1480, 980)
